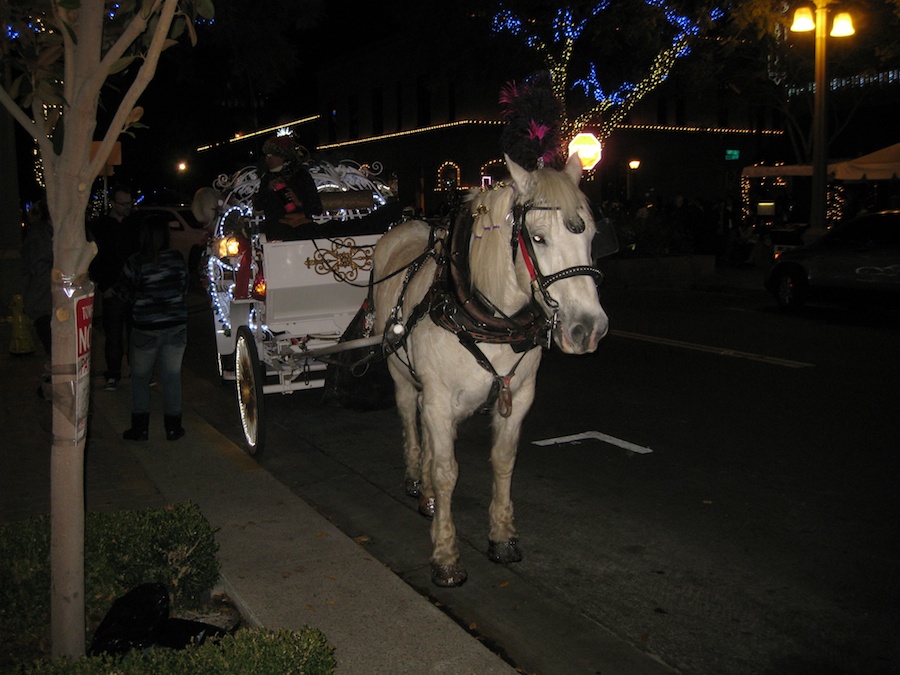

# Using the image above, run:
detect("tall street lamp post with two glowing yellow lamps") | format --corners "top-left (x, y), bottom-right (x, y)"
top-left (791, 0), bottom-right (854, 230)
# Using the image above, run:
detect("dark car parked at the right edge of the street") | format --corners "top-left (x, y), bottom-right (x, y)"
top-left (766, 211), bottom-right (900, 309)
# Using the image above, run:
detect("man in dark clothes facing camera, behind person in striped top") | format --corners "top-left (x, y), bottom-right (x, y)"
top-left (88, 185), bottom-right (138, 391)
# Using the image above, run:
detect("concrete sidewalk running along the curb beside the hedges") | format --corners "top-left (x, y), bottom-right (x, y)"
top-left (0, 327), bottom-right (515, 674)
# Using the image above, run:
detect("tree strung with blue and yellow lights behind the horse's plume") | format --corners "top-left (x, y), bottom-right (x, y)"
top-left (493, 0), bottom-right (721, 139)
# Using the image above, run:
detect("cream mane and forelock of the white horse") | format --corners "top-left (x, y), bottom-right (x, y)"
top-left (469, 168), bottom-right (593, 311)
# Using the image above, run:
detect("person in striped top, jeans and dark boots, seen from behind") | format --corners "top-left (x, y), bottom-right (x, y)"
top-left (114, 216), bottom-right (188, 441)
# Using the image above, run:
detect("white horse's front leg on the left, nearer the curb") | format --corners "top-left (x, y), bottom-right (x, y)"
top-left (422, 405), bottom-right (468, 587)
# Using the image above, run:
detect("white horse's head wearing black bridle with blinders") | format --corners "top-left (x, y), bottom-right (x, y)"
top-left (506, 155), bottom-right (609, 354)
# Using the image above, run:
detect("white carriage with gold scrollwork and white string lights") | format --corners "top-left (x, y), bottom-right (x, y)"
top-left (208, 162), bottom-right (399, 454)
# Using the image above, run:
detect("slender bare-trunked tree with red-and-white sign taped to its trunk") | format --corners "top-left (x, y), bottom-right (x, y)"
top-left (0, 0), bottom-right (213, 657)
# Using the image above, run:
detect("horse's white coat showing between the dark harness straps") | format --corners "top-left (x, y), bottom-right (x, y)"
top-left (375, 157), bottom-right (608, 585)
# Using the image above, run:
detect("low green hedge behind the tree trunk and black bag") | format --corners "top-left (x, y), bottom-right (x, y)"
top-left (0, 502), bottom-right (219, 671)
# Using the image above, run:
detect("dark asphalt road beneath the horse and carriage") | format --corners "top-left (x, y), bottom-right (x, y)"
top-left (186, 289), bottom-right (900, 675)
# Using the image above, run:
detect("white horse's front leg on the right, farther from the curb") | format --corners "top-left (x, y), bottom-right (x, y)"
top-left (488, 377), bottom-right (534, 564)
